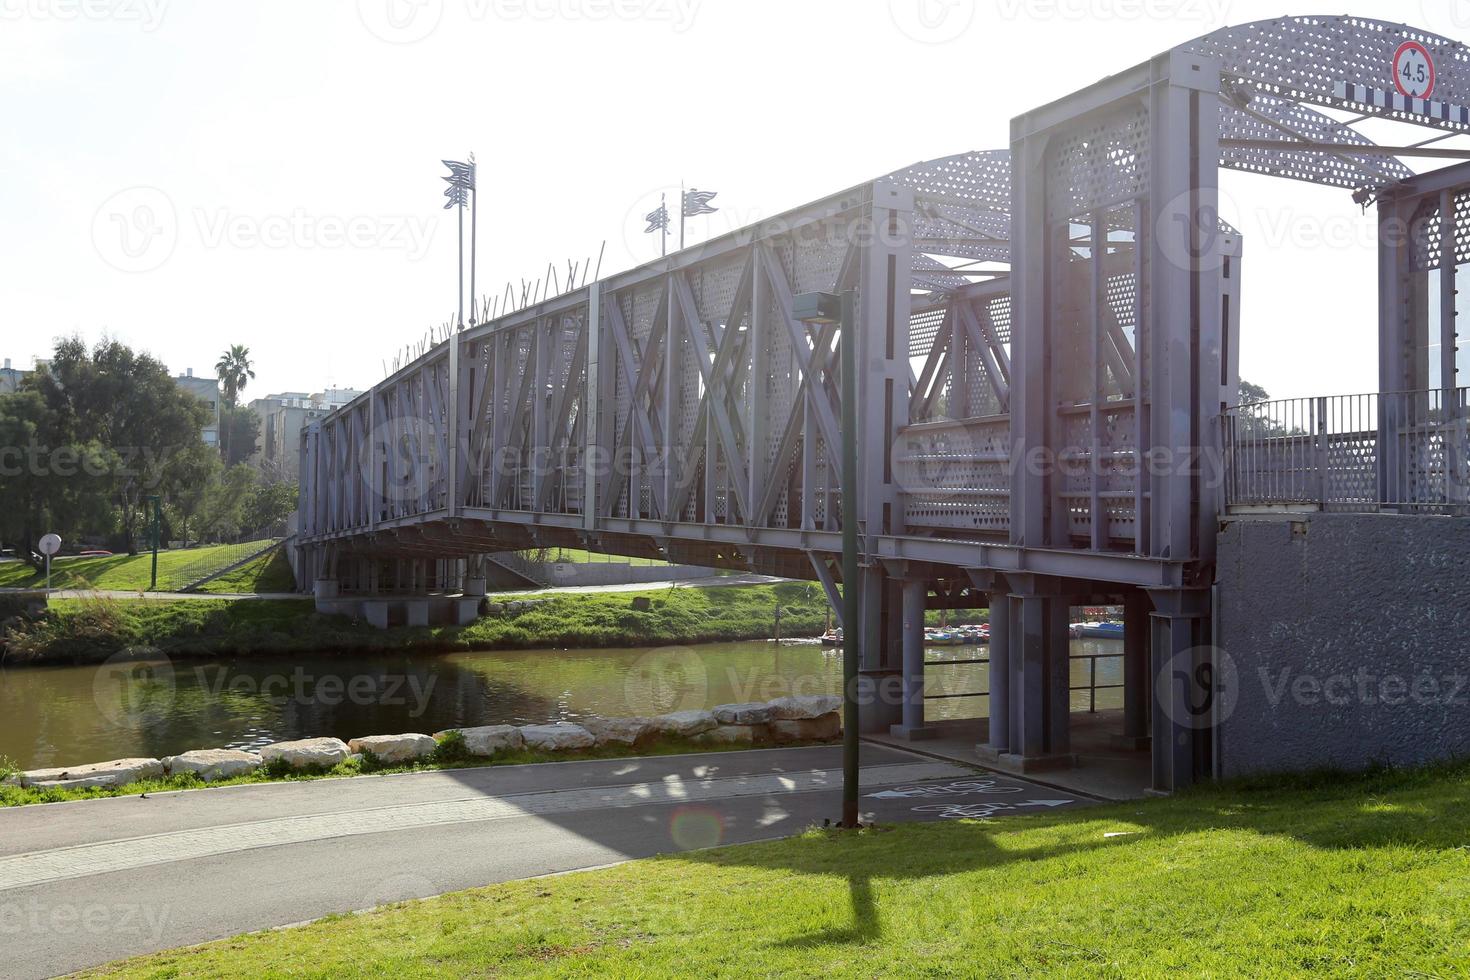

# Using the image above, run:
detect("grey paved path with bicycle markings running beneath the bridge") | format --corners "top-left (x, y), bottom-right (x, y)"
top-left (0, 745), bottom-right (1083, 977)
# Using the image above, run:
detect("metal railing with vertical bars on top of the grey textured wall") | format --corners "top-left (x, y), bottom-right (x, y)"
top-left (1223, 388), bottom-right (1470, 514)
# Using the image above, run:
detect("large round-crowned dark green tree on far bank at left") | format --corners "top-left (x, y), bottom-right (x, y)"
top-left (26, 336), bottom-right (209, 554)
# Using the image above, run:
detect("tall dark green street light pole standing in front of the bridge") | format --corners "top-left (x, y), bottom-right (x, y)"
top-left (792, 289), bottom-right (860, 829)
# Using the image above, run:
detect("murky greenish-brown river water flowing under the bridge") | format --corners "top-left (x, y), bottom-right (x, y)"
top-left (0, 639), bottom-right (1122, 768)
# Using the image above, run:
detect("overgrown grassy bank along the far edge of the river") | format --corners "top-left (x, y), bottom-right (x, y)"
top-left (7, 583), bottom-right (825, 663)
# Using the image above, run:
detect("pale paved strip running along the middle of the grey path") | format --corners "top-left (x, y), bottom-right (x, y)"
top-left (0, 763), bottom-right (969, 892)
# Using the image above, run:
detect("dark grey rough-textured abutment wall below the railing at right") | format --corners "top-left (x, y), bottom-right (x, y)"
top-left (1217, 514), bottom-right (1470, 776)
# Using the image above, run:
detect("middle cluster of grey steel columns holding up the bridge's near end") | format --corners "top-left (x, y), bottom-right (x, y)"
top-left (976, 576), bottom-right (1076, 773)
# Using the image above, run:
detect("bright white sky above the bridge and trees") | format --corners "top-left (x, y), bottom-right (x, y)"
top-left (0, 0), bottom-right (1470, 398)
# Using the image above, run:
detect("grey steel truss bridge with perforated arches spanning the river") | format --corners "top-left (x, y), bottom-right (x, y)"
top-left (297, 16), bottom-right (1470, 790)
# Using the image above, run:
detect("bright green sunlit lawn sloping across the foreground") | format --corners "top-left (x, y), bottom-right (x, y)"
top-left (83, 767), bottom-right (1470, 977)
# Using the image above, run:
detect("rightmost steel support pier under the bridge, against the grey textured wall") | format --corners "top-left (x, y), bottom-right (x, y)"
top-left (1150, 589), bottom-right (1219, 793)
